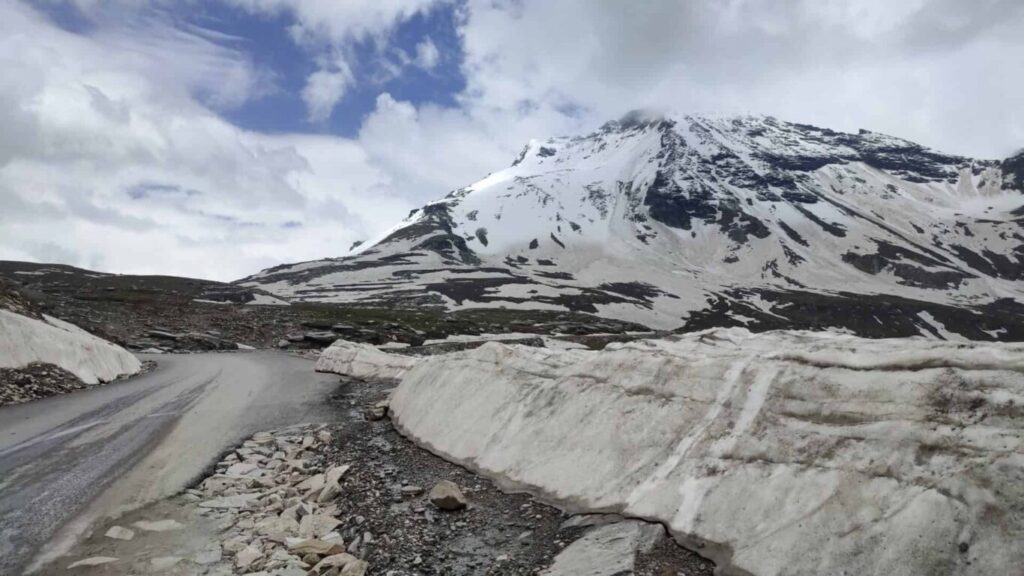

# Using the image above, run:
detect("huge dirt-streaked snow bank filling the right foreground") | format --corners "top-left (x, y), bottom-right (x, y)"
top-left (390, 329), bottom-right (1024, 576)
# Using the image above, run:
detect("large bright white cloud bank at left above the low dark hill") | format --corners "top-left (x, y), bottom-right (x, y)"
top-left (0, 4), bottom-right (413, 280)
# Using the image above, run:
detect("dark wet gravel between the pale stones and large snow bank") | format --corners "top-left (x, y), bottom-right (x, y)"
top-left (315, 380), bottom-right (714, 576)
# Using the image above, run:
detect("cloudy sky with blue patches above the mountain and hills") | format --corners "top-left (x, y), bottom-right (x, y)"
top-left (0, 0), bottom-right (1024, 280)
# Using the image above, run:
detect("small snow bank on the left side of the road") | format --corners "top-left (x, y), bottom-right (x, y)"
top-left (0, 310), bottom-right (141, 384)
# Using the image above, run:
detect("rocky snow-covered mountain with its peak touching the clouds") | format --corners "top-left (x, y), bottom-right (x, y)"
top-left (240, 113), bottom-right (1024, 340)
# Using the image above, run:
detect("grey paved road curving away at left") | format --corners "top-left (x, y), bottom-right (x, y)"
top-left (0, 352), bottom-right (338, 575)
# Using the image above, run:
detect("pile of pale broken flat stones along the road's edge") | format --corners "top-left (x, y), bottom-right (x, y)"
top-left (188, 425), bottom-right (372, 576)
